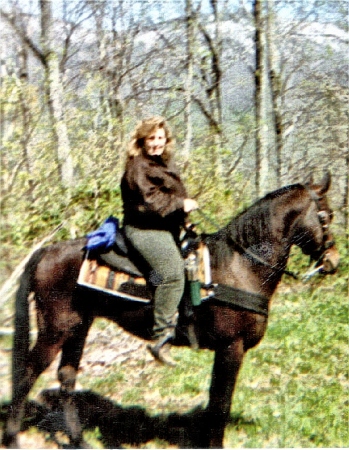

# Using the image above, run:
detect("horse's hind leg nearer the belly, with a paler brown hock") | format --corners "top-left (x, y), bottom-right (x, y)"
top-left (58, 319), bottom-right (92, 448)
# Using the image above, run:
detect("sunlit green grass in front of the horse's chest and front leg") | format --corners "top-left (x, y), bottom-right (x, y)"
top-left (226, 280), bottom-right (349, 448)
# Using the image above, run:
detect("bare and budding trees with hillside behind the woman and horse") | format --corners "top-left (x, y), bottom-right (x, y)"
top-left (0, 0), bottom-right (349, 288)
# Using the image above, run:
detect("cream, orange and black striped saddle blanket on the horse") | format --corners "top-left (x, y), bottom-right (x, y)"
top-left (77, 244), bottom-right (211, 303)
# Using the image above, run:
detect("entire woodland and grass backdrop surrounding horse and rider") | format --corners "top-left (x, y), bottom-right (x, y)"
top-left (0, 0), bottom-right (349, 448)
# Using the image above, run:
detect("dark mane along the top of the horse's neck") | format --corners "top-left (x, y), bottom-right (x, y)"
top-left (205, 184), bottom-right (305, 258)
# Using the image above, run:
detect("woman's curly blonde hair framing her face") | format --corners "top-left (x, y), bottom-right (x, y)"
top-left (127, 116), bottom-right (174, 160)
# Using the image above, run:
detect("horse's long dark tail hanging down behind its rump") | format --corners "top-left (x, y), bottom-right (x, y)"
top-left (12, 248), bottom-right (45, 398)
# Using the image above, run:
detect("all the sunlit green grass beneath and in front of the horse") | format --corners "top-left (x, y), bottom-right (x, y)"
top-left (0, 253), bottom-right (349, 448)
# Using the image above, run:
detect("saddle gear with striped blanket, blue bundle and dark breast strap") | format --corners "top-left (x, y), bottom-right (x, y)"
top-left (77, 218), bottom-right (269, 326)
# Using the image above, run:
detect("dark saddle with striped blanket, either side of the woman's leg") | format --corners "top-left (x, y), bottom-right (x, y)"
top-left (77, 218), bottom-right (211, 306)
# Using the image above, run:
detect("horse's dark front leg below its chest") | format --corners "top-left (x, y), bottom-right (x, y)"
top-left (207, 339), bottom-right (244, 448)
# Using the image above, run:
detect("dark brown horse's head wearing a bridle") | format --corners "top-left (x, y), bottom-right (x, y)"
top-left (293, 172), bottom-right (339, 273)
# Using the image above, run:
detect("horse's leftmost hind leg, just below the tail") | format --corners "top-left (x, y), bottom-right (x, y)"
top-left (2, 334), bottom-right (62, 448)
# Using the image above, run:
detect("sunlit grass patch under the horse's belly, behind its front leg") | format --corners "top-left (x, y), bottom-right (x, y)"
top-left (79, 342), bottom-right (213, 414)
